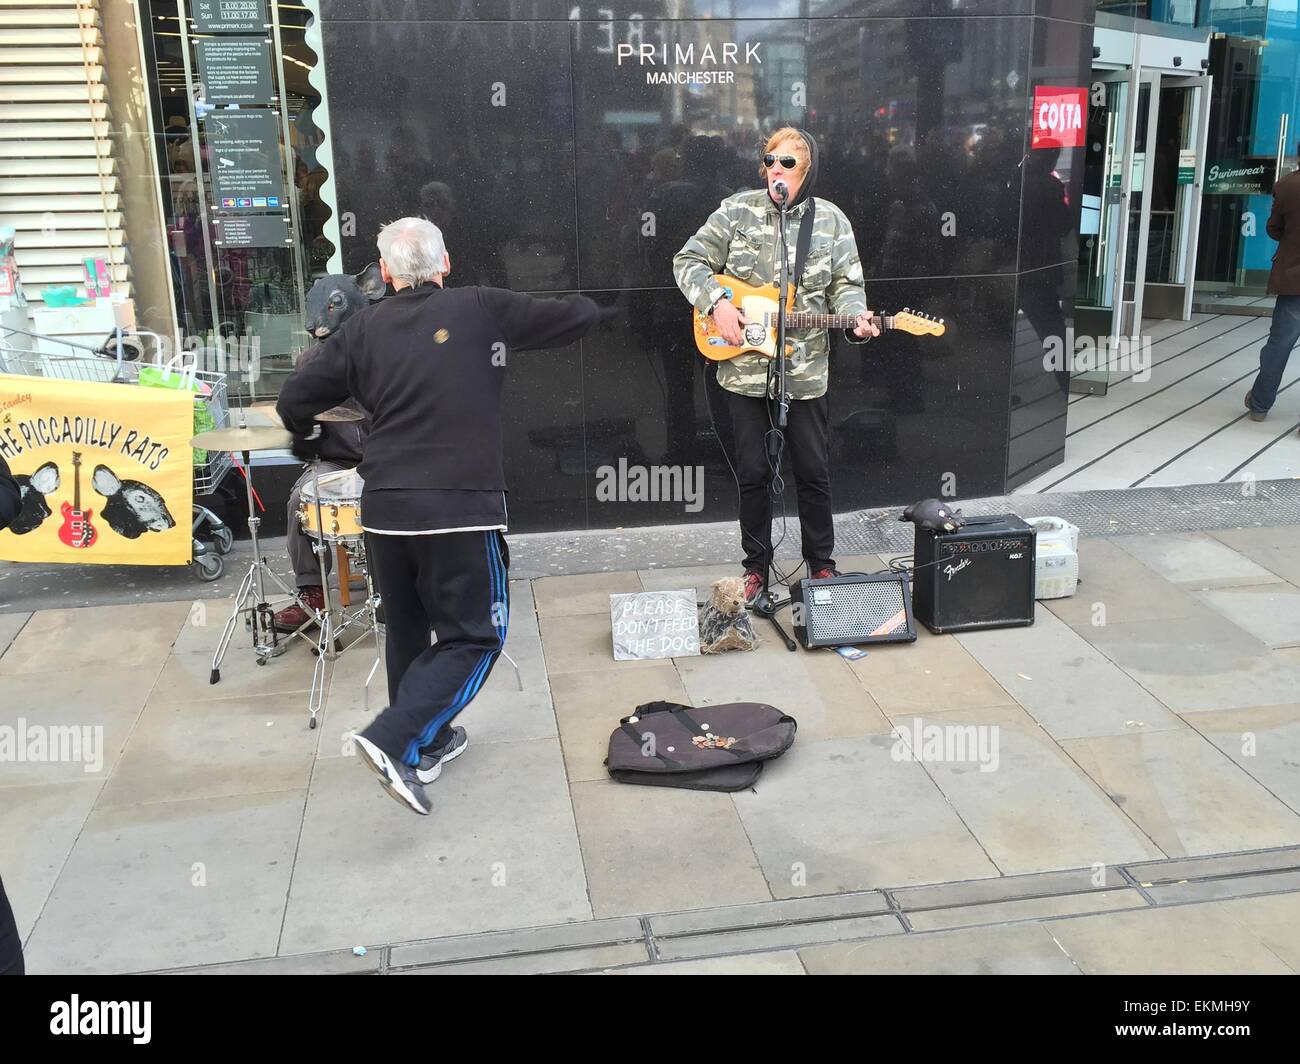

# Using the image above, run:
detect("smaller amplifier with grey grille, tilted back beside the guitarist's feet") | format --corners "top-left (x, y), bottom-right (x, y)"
top-left (790, 572), bottom-right (917, 649)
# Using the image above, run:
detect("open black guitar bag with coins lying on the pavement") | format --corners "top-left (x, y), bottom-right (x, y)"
top-left (605, 702), bottom-right (798, 791)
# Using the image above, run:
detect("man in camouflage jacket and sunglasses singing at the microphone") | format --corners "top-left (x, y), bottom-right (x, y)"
top-left (672, 126), bottom-right (880, 602)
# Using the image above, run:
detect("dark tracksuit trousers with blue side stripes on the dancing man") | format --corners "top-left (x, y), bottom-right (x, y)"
top-left (361, 531), bottom-right (510, 765)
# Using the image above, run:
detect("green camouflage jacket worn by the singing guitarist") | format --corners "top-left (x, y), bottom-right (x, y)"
top-left (672, 189), bottom-right (867, 399)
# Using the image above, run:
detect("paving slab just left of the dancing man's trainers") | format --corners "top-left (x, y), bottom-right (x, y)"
top-left (98, 697), bottom-right (321, 809)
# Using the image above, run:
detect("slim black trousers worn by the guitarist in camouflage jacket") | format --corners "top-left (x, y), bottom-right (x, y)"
top-left (724, 392), bottom-right (835, 572)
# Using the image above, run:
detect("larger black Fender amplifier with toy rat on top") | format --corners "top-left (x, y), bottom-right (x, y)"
top-left (911, 514), bottom-right (1037, 632)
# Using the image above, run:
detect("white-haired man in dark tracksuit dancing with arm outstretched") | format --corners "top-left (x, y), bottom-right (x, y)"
top-left (277, 217), bottom-right (612, 814)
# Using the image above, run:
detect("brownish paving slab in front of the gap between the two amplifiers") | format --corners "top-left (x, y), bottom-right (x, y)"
top-left (848, 624), bottom-right (1013, 717)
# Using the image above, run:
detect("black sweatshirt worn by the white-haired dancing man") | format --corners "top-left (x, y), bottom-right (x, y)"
top-left (276, 285), bottom-right (601, 531)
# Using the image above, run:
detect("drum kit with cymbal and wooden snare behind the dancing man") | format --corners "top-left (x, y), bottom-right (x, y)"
top-left (190, 406), bottom-right (381, 728)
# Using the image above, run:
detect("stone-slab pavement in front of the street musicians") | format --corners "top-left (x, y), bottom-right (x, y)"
top-left (0, 525), bottom-right (1300, 973)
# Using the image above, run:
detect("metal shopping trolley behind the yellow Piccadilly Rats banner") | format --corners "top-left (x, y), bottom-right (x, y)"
top-left (0, 325), bottom-right (235, 580)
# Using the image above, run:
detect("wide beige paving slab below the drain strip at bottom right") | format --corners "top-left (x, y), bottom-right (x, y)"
top-left (1044, 901), bottom-right (1292, 976)
